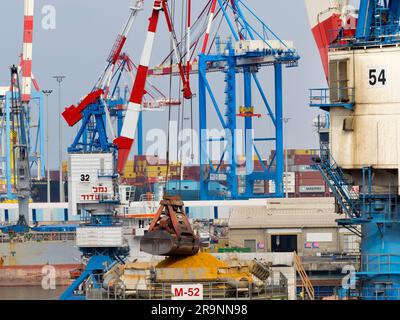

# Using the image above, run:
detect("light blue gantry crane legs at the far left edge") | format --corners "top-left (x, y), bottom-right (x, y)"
top-left (0, 91), bottom-right (47, 200)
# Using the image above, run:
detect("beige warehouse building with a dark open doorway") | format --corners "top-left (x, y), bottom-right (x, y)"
top-left (229, 198), bottom-right (359, 256)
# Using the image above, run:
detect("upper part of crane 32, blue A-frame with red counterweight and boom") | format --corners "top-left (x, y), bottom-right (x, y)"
top-left (62, 0), bottom-right (180, 154)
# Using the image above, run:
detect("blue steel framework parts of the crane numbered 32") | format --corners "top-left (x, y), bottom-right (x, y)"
top-left (60, 60), bottom-right (134, 300)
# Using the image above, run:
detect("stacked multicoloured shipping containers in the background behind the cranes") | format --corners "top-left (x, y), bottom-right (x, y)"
top-left (24, 149), bottom-right (331, 202)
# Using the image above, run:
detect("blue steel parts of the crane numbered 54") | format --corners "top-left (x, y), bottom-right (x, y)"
top-left (311, 0), bottom-right (400, 300)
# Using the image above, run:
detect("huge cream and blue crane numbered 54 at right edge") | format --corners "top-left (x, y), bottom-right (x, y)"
top-left (306, 0), bottom-right (400, 300)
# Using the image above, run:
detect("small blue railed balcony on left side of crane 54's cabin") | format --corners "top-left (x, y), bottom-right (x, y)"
top-left (310, 87), bottom-right (355, 108)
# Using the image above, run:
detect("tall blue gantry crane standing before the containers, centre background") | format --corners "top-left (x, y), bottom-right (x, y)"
top-left (199, 0), bottom-right (300, 200)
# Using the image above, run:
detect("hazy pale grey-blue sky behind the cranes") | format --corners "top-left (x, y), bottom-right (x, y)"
top-left (0, 0), bottom-right (326, 167)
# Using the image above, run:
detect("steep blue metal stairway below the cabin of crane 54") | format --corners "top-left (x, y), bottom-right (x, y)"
top-left (313, 146), bottom-right (360, 218)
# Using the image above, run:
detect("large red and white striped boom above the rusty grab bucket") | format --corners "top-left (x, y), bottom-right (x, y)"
top-left (114, 0), bottom-right (193, 173)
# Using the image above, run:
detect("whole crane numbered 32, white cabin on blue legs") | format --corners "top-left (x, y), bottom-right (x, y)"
top-left (61, 1), bottom-right (195, 300)
